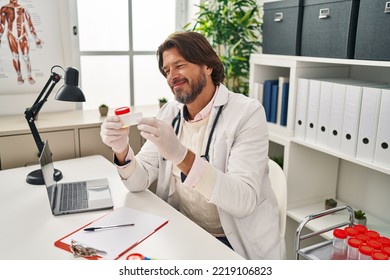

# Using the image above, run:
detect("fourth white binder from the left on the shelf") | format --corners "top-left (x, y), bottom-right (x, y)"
top-left (328, 83), bottom-right (346, 152)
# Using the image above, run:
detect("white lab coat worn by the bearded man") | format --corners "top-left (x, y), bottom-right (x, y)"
top-left (125, 85), bottom-right (285, 259)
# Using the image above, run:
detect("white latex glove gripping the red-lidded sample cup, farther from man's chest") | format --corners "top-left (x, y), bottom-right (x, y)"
top-left (100, 116), bottom-right (129, 153)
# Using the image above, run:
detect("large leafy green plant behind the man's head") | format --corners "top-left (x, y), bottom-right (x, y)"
top-left (184, 0), bottom-right (262, 95)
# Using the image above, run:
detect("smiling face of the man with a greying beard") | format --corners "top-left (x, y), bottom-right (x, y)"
top-left (163, 48), bottom-right (206, 104)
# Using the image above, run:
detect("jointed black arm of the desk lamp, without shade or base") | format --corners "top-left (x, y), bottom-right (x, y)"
top-left (24, 72), bottom-right (61, 155)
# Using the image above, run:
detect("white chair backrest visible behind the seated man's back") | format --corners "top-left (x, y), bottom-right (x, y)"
top-left (268, 159), bottom-right (287, 237)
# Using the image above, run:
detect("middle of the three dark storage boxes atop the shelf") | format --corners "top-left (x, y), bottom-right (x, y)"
top-left (301, 0), bottom-right (359, 58)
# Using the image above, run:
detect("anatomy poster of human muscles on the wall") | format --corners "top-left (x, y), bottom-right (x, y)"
top-left (0, 0), bottom-right (63, 94)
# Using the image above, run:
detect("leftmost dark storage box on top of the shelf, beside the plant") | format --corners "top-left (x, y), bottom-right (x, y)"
top-left (262, 0), bottom-right (303, 55)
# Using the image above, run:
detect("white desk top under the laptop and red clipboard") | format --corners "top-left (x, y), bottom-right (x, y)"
top-left (0, 156), bottom-right (242, 260)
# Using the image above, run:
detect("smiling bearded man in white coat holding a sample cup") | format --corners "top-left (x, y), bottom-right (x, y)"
top-left (101, 32), bottom-right (285, 259)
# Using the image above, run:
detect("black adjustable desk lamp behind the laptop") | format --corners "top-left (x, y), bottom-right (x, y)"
top-left (24, 65), bottom-right (85, 185)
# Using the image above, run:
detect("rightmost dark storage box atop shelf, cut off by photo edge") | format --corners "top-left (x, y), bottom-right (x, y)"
top-left (355, 0), bottom-right (390, 60)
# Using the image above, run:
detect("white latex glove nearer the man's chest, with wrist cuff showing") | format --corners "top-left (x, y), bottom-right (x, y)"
top-left (138, 118), bottom-right (187, 165)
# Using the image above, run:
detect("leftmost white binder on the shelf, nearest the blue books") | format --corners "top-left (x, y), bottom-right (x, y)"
top-left (294, 78), bottom-right (310, 140)
